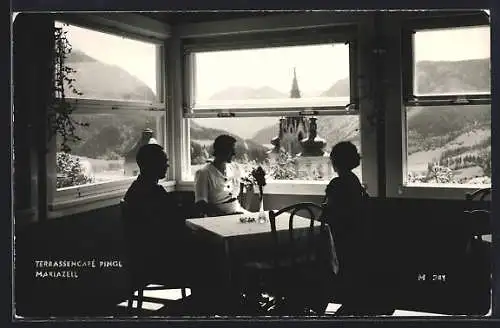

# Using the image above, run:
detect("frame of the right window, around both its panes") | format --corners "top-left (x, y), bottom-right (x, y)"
top-left (386, 12), bottom-right (491, 199)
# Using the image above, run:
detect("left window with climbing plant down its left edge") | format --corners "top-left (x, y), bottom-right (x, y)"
top-left (53, 22), bottom-right (166, 192)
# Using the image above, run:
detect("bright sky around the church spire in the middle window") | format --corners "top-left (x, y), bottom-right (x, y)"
top-left (195, 44), bottom-right (349, 100)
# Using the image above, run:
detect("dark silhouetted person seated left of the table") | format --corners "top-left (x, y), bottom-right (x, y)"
top-left (124, 144), bottom-right (185, 275)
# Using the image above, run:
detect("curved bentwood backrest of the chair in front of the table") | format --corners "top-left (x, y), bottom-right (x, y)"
top-left (269, 202), bottom-right (326, 265)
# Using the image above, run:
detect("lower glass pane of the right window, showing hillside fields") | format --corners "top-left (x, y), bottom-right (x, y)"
top-left (406, 105), bottom-right (491, 186)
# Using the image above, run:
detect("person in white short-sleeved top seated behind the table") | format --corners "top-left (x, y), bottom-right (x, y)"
top-left (194, 134), bottom-right (247, 216)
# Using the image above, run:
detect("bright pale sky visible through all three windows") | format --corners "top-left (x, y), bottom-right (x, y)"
top-left (57, 20), bottom-right (490, 101)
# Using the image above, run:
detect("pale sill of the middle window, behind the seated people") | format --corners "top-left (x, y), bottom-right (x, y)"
top-left (176, 180), bottom-right (328, 195)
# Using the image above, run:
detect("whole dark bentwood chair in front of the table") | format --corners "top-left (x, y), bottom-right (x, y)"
top-left (269, 202), bottom-right (338, 315)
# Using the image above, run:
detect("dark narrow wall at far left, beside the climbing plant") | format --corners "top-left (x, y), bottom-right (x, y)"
top-left (13, 13), bottom-right (54, 221)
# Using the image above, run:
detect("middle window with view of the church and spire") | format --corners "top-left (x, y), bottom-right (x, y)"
top-left (183, 38), bottom-right (361, 187)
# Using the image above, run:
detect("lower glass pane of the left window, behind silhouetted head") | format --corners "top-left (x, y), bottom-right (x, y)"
top-left (56, 112), bottom-right (163, 188)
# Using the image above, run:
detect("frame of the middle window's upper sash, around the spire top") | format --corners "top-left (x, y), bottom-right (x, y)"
top-left (182, 26), bottom-right (359, 118)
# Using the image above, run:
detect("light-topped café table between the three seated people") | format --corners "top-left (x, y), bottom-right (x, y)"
top-left (186, 213), bottom-right (338, 284)
